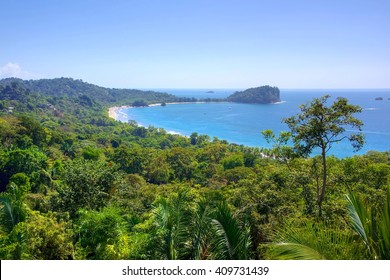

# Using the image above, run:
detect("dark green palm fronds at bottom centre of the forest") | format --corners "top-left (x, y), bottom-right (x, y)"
top-left (153, 196), bottom-right (251, 260)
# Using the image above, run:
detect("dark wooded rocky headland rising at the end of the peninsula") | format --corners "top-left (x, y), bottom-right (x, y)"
top-left (227, 86), bottom-right (280, 104)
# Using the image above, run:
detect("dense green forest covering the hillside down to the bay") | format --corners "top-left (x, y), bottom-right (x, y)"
top-left (0, 79), bottom-right (390, 259)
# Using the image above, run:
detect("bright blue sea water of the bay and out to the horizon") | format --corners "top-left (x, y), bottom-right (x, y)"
top-left (118, 89), bottom-right (390, 158)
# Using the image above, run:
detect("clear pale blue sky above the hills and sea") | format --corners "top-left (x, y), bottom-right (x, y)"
top-left (0, 0), bottom-right (390, 89)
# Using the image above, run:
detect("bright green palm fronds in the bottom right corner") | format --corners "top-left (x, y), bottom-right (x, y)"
top-left (270, 188), bottom-right (390, 260)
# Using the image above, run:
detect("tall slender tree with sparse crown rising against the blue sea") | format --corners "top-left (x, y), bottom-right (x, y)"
top-left (283, 95), bottom-right (364, 216)
